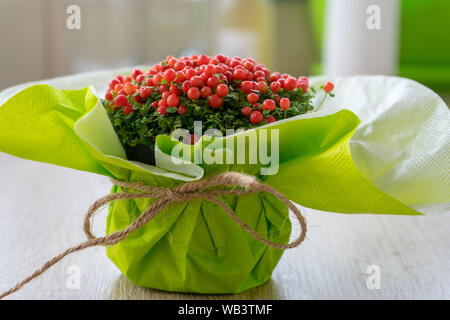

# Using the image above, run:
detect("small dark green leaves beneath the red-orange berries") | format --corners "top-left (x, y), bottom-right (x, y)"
top-left (102, 81), bottom-right (313, 147)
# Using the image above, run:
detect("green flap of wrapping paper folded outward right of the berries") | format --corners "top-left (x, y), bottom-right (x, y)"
top-left (157, 110), bottom-right (422, 215)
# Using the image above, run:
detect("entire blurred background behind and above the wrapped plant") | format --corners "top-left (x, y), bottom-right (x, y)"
top-left (0, 0), bottom-right (450, 101)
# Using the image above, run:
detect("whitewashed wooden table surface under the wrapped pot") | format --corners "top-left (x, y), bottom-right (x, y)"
top-left (0, 153), bottom-right (450, 299)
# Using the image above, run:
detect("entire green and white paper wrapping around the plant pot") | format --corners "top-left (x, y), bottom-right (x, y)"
top-left (0, 71), bottom-right (450, 293)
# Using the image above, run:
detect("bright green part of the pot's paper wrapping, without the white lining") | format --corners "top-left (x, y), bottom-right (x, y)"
top-left (0, 85), bottom-right (420, 293)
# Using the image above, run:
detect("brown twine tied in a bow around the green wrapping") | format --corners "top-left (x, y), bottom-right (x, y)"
top-left (0, 172), bottom-right (306, 299)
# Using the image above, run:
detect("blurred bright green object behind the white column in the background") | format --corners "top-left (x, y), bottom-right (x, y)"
top-left (309, 0), bottom-right (450, 91)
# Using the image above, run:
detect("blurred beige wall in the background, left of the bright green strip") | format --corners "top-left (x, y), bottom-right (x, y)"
top-left (0, 0), bottom-right (315, 90)
